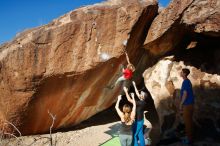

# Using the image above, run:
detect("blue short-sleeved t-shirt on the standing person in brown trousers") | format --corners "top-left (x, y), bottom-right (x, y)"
top-left (180, 79), bottom-right (194, 105)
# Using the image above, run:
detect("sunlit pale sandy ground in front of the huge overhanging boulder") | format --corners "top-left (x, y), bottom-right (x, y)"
top-left (1, 122), bottom-right (120, 146)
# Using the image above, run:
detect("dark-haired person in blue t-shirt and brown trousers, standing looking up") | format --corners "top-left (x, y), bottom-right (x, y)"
top-left (180, 68), bottom-right (194, 144)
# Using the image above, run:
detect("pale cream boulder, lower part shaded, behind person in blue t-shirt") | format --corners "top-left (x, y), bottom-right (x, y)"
top-left (143, 56), bottom-right (220, 137)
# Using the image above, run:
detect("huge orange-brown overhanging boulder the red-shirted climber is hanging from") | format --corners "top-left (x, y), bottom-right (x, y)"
top-left (0, 0), bottom-right (158, 135)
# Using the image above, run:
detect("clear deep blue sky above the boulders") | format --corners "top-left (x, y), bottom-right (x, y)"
top-left (0, 0), bottom-right (170, 44)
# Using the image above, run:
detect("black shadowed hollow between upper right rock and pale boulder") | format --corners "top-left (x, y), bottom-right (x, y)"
top-left (165, 34), bottom-right (220, 75)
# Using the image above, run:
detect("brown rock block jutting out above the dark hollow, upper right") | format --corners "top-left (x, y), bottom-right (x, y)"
top-left (144, 0), bottom-right (220, 55)
